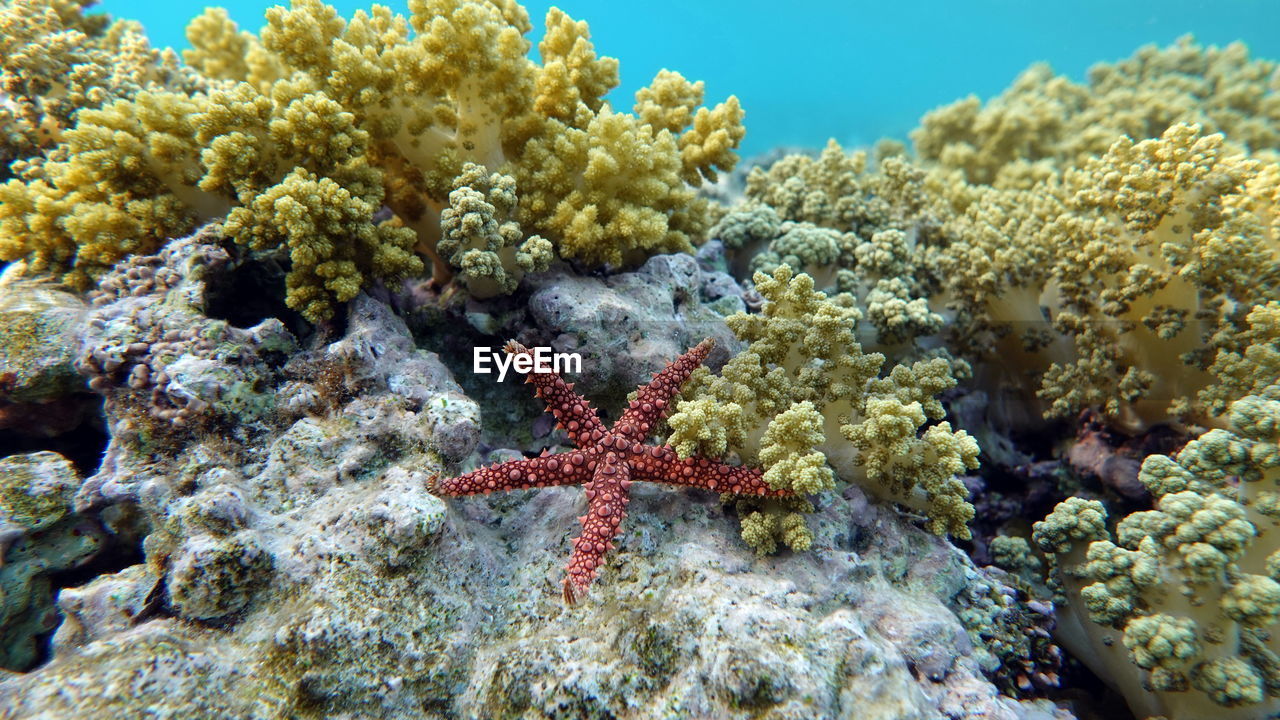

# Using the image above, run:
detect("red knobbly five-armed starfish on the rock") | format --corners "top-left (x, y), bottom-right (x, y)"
top-left (431, 338), bottom-right (791, 605)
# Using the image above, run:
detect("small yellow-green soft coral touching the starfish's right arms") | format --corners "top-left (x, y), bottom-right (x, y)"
top-left (668, 265), bottom-right (978, 547)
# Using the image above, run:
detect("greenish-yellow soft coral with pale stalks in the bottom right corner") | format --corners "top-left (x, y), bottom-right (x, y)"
top-left (1034, 384), bottom-right (1280, 720)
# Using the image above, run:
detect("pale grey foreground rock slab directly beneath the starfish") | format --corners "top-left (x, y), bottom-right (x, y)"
top-left (0, 450), bottom-right (1064, 720)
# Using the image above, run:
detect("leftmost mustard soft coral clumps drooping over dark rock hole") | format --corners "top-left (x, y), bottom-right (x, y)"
top-left (0, 75), bottom-right (421, 320)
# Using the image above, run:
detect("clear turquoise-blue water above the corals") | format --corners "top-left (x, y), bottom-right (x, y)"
top-left (100, 0), bottom-right (1280, 156)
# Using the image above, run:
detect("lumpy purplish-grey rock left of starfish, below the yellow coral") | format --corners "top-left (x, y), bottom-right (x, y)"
top-left (62, 225), bottom-right (477, 621)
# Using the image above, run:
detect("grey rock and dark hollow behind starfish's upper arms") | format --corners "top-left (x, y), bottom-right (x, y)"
top-left (404, 241), bottom-right (746, 430)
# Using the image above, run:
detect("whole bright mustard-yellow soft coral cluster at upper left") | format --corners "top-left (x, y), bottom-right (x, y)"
top-left (0, 0), bottom-right (744, 320)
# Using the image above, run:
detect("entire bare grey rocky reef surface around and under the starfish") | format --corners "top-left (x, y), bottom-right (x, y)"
top-left (0, 225), bottom-right (1066, 719)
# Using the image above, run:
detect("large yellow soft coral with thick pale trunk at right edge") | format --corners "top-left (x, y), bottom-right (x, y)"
top-left (1037, 124), bottom-right (1280, 424)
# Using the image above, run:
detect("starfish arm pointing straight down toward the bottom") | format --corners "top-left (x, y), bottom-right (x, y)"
top-left (564, 451), bottom-right (631, 605)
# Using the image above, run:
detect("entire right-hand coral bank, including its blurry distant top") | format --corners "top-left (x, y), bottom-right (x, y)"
top-left (713, 38), bottom-right (1280, 432)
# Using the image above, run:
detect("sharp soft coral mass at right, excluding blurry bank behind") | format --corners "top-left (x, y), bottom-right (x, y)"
top-left (732, 116), bottom-right (1280, 430)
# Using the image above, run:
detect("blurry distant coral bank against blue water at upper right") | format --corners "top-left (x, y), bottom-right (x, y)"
top-left (911, 36), bottom-right (1280, 187)
